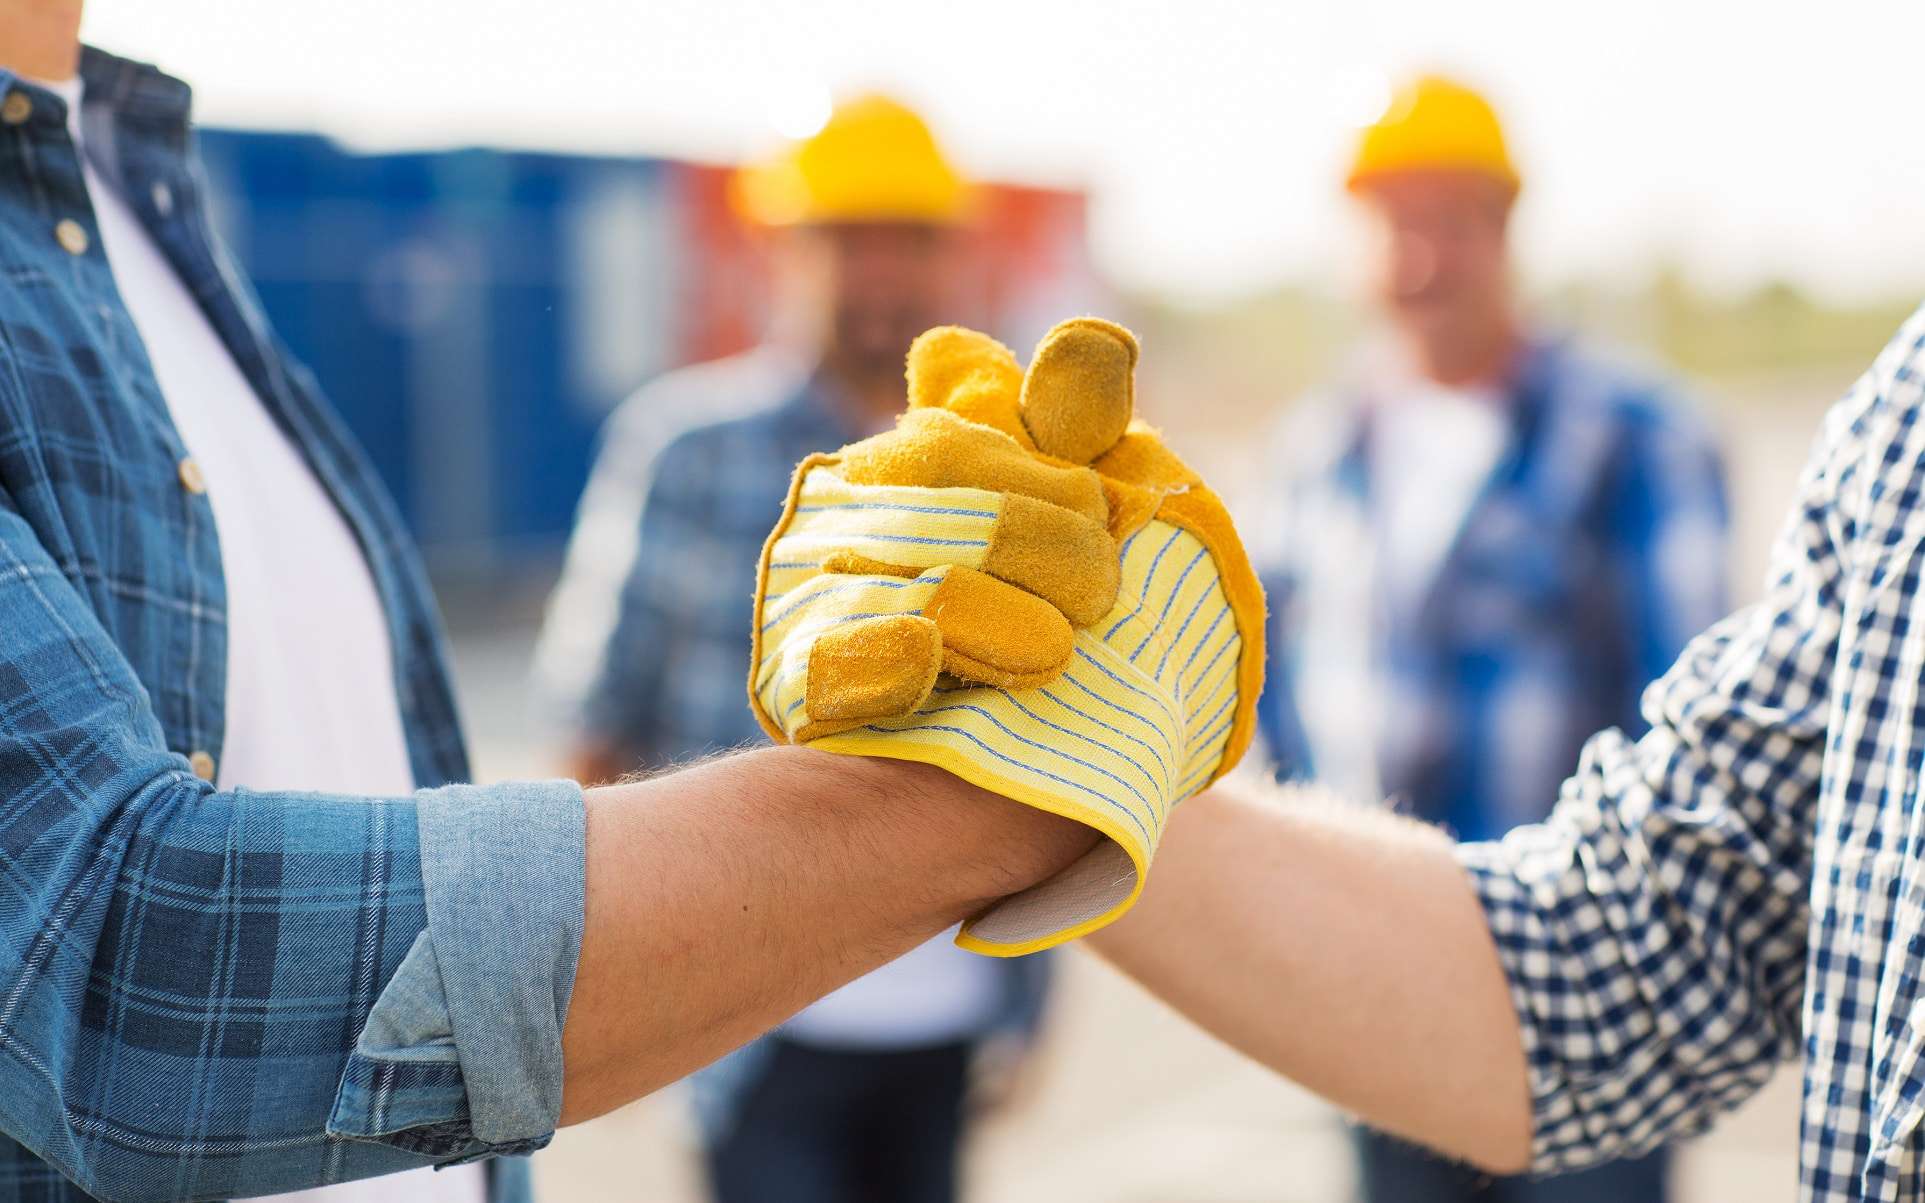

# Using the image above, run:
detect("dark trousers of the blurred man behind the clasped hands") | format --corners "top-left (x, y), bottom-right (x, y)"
top-left (708, 1036), bottom-right (972, 1203)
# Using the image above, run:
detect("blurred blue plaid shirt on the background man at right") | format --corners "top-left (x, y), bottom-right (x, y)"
top-left (1255, 341), bottom-right (1727, 839)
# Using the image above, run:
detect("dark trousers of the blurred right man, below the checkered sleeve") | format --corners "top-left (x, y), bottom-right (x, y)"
top-left (1351, 1128), bottom-right (1671, 1203)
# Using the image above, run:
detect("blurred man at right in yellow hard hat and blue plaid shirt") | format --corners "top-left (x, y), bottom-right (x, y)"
top-left (1251, 77), bottom-right (1727, 1203)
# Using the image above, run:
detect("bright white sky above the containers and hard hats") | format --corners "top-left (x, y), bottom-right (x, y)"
top-left (87, 0), bottom-right (1925, 298)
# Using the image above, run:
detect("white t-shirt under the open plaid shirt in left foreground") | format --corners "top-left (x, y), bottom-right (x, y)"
top-left (42, 79), bottom-right (487, 1203)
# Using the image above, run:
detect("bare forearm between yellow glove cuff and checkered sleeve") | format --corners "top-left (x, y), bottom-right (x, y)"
top-left (1091, 773), bottom-right (1530, 1172)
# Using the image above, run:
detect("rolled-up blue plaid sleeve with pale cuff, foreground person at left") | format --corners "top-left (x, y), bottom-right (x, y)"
top-left (0, 491), bottom-right (585, 1201)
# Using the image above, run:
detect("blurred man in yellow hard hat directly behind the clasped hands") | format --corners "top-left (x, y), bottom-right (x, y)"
top-left (541, 96), bottom-right (1047, 1203)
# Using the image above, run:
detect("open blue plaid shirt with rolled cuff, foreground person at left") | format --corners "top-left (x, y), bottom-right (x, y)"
top-left (0, 50), bottom-right (583, 1201)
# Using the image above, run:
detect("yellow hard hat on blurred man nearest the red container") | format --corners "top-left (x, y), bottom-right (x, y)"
top-left (730, 96), bottom-right (968, 225)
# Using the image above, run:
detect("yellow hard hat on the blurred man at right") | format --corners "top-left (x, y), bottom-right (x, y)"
top-left (1344, 75), bottom-right (1519, 192)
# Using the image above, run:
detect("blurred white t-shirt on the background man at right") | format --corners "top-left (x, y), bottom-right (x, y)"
top-left (1371, 381), bottom-right (1509, 604)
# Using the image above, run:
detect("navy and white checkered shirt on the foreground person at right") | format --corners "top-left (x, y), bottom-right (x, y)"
top-left (1461, 310), bottom-right (1925, 1201)
